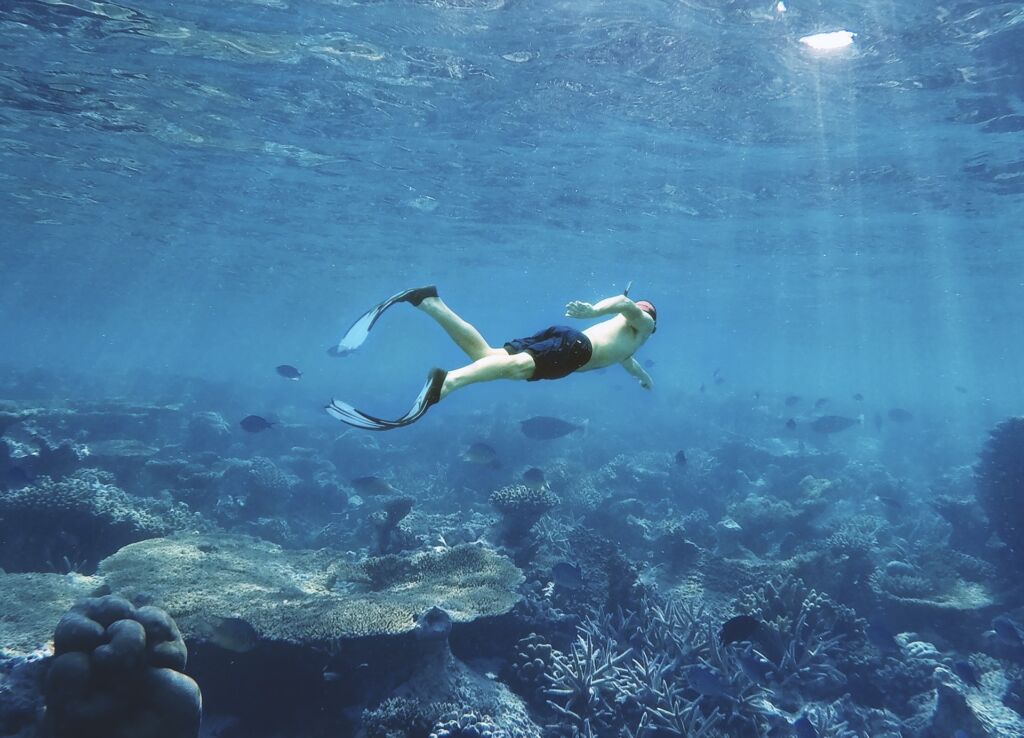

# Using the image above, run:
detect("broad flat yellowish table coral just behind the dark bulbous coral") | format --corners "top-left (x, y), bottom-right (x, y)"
top-left (98, 534), bottom-right (522, 644)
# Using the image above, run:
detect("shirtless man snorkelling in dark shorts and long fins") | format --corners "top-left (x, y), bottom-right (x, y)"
top-left (327, 286), bottom-right (657, 431)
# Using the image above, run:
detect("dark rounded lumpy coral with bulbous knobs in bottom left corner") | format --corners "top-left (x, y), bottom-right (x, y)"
top-left (44, 596), bottom-right (203, 738)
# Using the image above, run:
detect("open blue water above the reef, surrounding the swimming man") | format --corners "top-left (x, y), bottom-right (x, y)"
top-left (0, 0), bottom-right (1024, 732)
